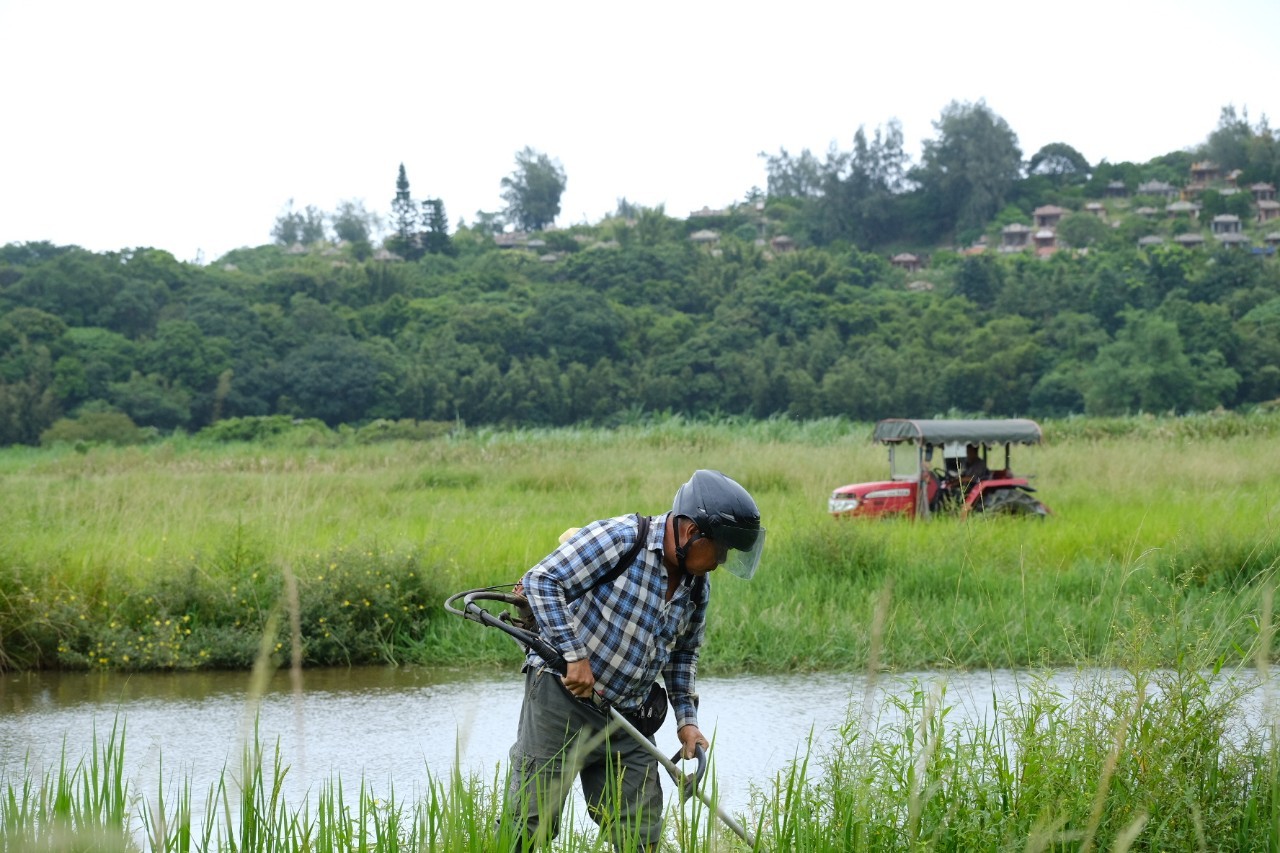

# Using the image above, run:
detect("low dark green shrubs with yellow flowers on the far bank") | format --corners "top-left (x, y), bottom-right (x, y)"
top-left (35, 534), bottom-right (444, 671)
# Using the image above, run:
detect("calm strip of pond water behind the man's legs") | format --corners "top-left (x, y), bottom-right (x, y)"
top-left (0, 667), bottom-right (1271, 815)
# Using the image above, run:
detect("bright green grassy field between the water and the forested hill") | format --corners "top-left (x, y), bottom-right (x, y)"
top-left (0, 415), bottom-right (1280, 672)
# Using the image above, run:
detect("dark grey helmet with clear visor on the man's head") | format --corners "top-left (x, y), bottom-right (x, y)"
top-left (671, 469), bottom-right (764, 580)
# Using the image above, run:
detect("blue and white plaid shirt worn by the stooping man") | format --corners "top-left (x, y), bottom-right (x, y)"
top-left (524, 512), bottom-right (710, 727)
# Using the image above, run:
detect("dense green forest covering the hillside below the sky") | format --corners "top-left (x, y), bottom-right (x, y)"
top-left (0, 102), bottom-right (1280, 444)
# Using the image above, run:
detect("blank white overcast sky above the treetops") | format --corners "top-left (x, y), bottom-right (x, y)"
top-left (0, 0), bottom-right (1280, 263)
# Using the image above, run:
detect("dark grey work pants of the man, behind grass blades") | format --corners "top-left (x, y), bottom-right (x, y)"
top-left (506, 670), bottom-right (662, 852)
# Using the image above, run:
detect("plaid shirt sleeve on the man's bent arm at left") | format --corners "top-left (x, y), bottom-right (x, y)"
top-left (524, 519), bottom-right (639, 662)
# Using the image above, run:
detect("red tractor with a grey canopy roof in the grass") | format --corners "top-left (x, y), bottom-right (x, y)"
top-left (827, 418), bottom-right (1048, 519)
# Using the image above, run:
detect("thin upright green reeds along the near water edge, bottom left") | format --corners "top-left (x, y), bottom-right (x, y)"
top-left (0, 725), bottom-right (655, 853)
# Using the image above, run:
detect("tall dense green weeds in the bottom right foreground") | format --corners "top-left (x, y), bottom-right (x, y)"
top-left (758, 671), bottom-right (1280, 850)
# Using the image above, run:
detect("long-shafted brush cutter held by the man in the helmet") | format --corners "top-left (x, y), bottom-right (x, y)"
top-left (444, 587), bottom-right (755, 848)
